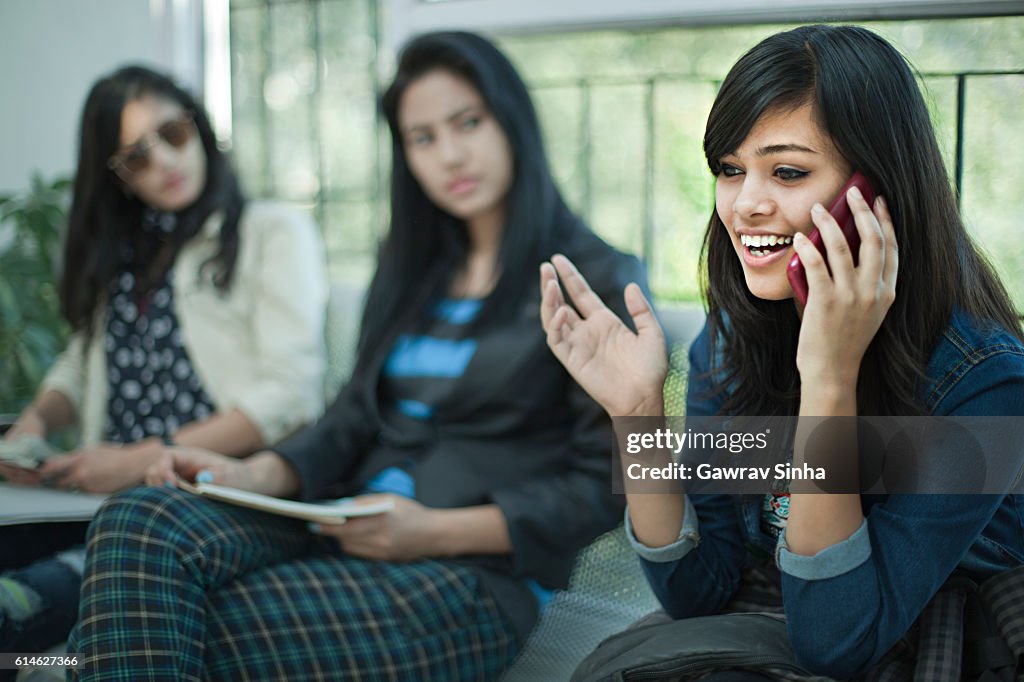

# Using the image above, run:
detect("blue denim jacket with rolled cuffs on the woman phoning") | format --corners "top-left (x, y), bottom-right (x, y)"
top-left (627, 311), bottom-right (1024, 678)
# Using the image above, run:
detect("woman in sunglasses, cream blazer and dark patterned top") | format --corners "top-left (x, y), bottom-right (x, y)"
top-left (0, 67), bottom-right (327, 651)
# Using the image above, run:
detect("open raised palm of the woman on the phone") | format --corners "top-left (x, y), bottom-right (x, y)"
top-left (541, 255), bottom-right (669, 417)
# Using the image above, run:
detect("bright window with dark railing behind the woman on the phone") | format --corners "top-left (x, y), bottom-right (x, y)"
top-left (501, 17), bottom-right (1024, 301)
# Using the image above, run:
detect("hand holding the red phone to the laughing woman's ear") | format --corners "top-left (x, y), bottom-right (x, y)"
top-left (794, 187), bottom-right (899, 390)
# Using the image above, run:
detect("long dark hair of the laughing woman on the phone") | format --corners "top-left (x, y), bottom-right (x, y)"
top-left (701, 26), bottom-right (1021, 415)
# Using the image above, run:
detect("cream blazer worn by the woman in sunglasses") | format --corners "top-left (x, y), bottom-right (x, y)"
top-left (41, 202), bottom-right (328, 445)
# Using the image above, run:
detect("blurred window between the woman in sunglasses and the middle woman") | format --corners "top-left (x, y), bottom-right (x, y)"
top-left (229, 0), bottom-right (389, 281)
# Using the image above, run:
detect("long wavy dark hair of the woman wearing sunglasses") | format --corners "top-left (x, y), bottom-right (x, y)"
top-left (59, 66), bottom-right (245, 333)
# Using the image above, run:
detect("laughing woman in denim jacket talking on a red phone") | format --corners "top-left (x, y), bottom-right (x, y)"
top-left (542, 26), bottom-right (1024, 679)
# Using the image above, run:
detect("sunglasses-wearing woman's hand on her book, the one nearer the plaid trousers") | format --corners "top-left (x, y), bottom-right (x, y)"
top-left (39, 442), bottom-right (163, 493)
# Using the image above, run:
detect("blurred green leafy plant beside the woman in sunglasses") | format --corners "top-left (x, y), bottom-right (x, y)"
top-left (0, 174), bottom-right (71, 413)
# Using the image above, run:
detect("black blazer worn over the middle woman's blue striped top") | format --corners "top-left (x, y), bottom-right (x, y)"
top-left (273, 227), bottom-right (646, 588)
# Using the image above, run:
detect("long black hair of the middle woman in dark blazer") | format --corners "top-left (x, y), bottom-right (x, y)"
top-left (359, 32), bottom-right (581, 365)
